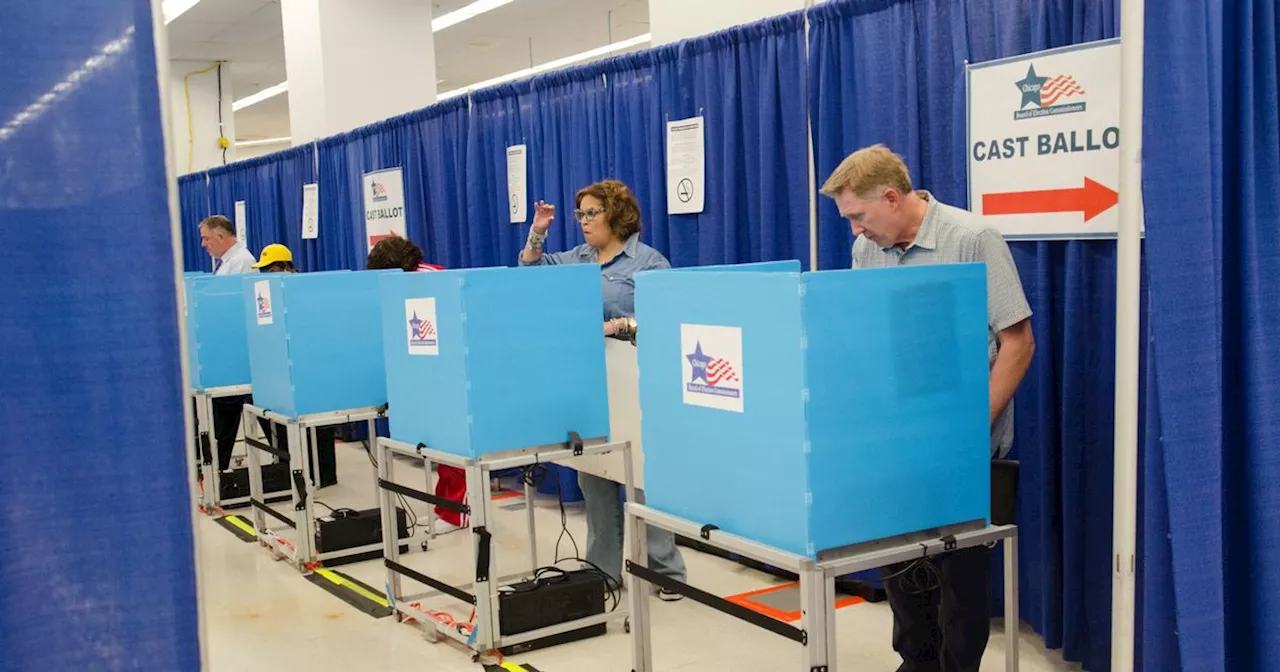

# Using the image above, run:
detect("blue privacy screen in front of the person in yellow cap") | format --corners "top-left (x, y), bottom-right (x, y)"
top-left (242, 270), bottom-right (389, 417)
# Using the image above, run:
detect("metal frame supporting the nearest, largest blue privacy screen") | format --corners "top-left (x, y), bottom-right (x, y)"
top-left (623, 502), bottom-right (1019, 672)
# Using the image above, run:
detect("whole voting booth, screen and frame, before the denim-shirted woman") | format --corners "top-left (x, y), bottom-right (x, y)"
top-left (376, 264), bottom-right (635, 653)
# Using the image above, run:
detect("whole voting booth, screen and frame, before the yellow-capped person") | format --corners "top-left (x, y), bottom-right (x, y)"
top-left (239, 270), bottom-right (394, 571)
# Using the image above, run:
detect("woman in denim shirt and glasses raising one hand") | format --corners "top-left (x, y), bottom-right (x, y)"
top-left (520, 179), bottom-right (685, 602)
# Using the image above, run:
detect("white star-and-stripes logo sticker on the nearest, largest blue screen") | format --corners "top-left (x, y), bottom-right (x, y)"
top-left (680, 324), bottom-right (746, 413)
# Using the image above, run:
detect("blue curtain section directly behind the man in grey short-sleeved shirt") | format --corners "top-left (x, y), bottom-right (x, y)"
top-left (809, 0), bottom-right (1119, 669)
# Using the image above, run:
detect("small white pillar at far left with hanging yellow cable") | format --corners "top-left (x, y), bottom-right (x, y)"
top-left (169, 60), bottom-right (237, 175)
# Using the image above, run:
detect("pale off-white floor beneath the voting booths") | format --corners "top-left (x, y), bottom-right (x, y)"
top-left (196, 444), bottom-right (1079, 672)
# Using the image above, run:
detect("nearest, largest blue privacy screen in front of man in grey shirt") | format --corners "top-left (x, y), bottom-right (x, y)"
top-left (636, 265), bottom-right (991, 557)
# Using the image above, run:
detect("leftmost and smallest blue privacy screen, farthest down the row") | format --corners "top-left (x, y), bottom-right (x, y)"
top-left (183, 273), bottom-right (250, 389)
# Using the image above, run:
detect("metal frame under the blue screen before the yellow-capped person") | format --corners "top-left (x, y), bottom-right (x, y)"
top-left (244, 403), bottom-right (384, 573)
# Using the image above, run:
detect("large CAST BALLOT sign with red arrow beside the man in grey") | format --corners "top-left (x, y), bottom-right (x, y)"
top-left (966, 40), bottom-right (1120, 239)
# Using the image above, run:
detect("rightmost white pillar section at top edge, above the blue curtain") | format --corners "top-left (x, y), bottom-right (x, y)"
top-left (649, 0), bottom-right (805, 46)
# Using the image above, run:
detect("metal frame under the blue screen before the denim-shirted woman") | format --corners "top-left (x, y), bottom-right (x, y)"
top-left (376, 433), bottom-right (636, 660)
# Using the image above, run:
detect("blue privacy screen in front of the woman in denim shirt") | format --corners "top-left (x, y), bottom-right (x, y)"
top-left (381, 264), bottom-right (609, 457)
